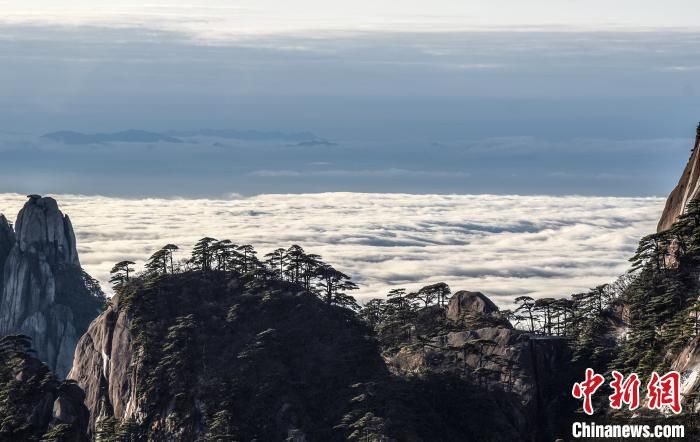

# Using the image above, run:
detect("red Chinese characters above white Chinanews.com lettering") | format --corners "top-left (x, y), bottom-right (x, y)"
top-left (571, 368), bottom-right (685, 439)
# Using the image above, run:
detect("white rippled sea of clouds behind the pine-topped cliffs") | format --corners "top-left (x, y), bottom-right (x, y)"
top-left (0, 193), bottom-right (664, 307)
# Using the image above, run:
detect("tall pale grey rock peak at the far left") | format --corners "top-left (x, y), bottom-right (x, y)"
top-left (0, 195), bottom-right (103, 377)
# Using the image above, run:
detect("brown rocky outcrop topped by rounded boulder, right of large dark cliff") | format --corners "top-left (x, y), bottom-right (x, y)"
top-left (386, 291), bottom-right (571, 439)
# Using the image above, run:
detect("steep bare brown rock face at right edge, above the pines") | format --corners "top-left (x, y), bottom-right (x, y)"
top-left (657, 121), bottom-right (700, 232)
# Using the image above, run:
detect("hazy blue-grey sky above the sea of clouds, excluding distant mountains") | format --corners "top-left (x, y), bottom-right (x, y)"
top-left (0, 0), bottom-right (700, 196)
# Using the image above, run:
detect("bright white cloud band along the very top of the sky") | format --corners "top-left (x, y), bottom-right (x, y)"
top-left (0, 0), bottom-right (698, 39)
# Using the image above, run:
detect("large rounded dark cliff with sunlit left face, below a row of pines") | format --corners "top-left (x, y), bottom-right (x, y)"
top-left (69, 273), bottom-right (382, 440)
